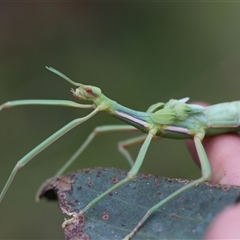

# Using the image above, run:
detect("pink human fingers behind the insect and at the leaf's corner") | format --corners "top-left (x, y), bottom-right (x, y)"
top-left (186, 103), bottom-right (240, 239)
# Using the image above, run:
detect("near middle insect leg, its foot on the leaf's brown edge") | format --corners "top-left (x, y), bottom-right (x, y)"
top-left (62, 129), bottom-right (157, 228)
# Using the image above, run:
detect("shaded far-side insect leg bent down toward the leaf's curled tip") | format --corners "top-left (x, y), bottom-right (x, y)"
top-left (55, 125), bottom-right (139, 176)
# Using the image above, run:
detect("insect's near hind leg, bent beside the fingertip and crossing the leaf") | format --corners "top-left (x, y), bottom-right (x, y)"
top-left (124, 135), bottom-right (211, 240)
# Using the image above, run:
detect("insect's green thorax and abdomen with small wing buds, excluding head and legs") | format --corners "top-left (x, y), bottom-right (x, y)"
top-left (110, 99), bottom-right (240, 139)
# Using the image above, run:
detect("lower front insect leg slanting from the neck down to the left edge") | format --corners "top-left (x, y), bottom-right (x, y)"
top-left (0, 108), bottom-right (99, 202)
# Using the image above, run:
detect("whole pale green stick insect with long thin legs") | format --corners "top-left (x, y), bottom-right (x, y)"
top-left (0, 67), bottom-right (240, 240)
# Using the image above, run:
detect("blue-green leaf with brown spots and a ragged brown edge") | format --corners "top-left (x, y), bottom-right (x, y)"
top-left (39, 168), bottom-right (240, 240)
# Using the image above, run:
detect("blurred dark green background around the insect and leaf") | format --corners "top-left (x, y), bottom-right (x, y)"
top-left (0, 1), bottom-right (240, 239)
